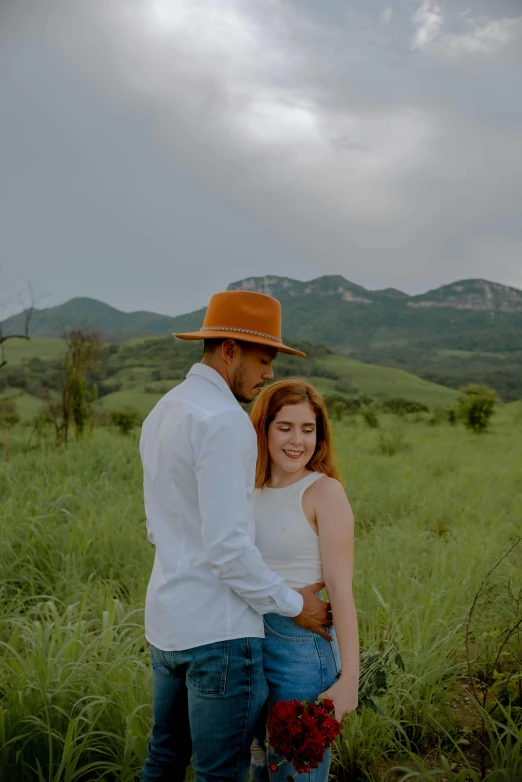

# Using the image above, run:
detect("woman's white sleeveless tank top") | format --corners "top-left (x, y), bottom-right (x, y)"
top-left (253, 472), bottom-right (323, 589)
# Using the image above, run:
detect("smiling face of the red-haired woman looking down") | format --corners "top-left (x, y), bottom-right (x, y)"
top-left (268, 402), bottom-right (317, 473)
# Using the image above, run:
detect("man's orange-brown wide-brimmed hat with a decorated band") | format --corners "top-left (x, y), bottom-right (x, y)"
top-left (173, 291), bottom-right (306, 358)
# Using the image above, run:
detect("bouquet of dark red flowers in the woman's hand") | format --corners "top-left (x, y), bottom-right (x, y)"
top-left (267, 699), bottom-right (342, 774)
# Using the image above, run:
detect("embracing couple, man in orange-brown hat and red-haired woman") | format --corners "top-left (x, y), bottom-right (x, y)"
top-left (140, 291), bottom-right (359, 782)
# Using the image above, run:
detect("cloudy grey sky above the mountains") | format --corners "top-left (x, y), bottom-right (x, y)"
top-left (0, 0), bottom-right (522, 314)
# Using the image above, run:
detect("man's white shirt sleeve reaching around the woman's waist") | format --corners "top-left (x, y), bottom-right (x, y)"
top-left (195, 410), bottom-right (303, 616)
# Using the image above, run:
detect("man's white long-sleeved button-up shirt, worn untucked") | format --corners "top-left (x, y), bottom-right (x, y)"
top-left (140, 364), bottom-right (303, 651)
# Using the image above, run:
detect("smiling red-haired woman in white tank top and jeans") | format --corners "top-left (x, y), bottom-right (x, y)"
top-left (251, 380), bottom-right (359, 782)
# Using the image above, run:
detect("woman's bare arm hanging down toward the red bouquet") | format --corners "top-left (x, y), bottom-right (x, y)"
top-left (310, 477), bottom-right (359, 720)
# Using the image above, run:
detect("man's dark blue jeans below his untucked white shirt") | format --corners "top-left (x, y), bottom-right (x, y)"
top-left (141, 638), bottom-right (268, 782)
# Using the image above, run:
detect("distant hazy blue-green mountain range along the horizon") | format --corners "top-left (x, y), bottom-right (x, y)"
top-left (3, 275), bottom-right (522, 401)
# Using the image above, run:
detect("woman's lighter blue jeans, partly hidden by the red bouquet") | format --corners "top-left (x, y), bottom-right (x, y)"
top-left (251, 614), bottom-right (341, 782)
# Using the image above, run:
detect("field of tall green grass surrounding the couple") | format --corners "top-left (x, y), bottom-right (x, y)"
top-left (0, 405), bottom-right (522, 782)
